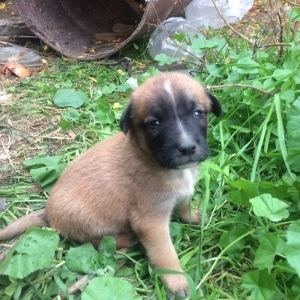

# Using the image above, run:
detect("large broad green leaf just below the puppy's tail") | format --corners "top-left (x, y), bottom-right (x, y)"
top-left (0, 228), bottom-right (59, 279)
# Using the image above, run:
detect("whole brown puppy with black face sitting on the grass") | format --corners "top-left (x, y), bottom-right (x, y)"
top-left (0, 73), bottom-right (222, 296)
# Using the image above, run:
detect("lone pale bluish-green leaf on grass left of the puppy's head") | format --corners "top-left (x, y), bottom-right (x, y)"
top-left (53, 89), bottom-right (88, 108)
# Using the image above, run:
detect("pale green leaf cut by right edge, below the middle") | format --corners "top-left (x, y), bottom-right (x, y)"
top-left (286, 220), bottom-right (300, 277)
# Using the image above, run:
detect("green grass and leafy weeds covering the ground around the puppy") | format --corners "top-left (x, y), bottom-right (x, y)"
top-left (0, 9), bottom-right (300, 300)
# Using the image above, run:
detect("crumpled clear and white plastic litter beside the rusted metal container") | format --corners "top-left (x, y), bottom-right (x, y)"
top-left (148, 0), bottom-right (253, 62)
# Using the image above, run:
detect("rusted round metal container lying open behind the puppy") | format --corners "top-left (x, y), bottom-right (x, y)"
top-left (14, 0), bottom-right (191, 60)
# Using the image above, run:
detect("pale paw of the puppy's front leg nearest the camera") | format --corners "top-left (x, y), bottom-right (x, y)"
top-left (161, 274), bottom-right (190, 300)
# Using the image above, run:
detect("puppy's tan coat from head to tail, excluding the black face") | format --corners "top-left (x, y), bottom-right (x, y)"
top-left (0, 73), bottom-right (220, 296)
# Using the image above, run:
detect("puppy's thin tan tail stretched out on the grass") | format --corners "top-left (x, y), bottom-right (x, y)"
top-left (0, 210), bottom-right (49, 241)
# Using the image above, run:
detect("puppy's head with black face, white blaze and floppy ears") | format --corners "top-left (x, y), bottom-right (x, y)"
top-left (120, 73), bottom-right (222, 169)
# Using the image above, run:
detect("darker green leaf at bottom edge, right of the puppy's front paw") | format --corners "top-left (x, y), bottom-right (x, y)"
top-left (242, 270), bottom-right (277, 300)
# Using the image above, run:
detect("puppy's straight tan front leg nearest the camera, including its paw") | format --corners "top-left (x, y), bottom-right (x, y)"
top-left (134, 216), bottom-right (189, 299)
